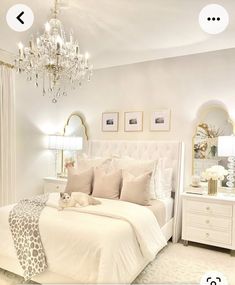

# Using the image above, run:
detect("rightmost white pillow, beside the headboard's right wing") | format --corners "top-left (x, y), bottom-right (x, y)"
top-left (155, 158), bottom-right (173, 199)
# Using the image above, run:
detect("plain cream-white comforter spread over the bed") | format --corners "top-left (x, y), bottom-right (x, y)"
top-left (0, 193), bottom-right (166, 283)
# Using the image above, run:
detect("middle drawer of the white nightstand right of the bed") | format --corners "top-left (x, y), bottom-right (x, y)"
top-left (186, 214), bottom-right (232, 234)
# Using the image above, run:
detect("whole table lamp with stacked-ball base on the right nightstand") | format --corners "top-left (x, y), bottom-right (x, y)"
top-left (218, 135), bottom-right (235, 189)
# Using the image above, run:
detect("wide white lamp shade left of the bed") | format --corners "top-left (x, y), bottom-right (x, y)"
top-left (48, 135), bottom-right (82, 150)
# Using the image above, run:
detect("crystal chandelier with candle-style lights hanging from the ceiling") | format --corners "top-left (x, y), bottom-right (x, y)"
top-left (15, 0), bottom-right (93, 103)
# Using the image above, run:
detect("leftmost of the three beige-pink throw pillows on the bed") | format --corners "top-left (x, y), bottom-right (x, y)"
top-left (65, 168), bottom-right (93, 195)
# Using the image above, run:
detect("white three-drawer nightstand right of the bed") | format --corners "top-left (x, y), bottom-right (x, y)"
top-left (182, 193), bottom-right (235, 253)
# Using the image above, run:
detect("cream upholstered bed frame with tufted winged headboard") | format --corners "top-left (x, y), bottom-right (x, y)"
top-left (0, 140), bottom-right (184, 284)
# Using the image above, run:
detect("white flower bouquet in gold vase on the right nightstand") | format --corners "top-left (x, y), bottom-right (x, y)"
top-left (202, 165), bottom-right (228, 195)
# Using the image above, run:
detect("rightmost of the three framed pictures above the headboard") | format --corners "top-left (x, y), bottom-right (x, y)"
top-left (150, 109), bottom-right (171, 132)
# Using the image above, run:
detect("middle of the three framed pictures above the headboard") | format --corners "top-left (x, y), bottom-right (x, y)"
top-left (124, 111), bottom-right (143, 132)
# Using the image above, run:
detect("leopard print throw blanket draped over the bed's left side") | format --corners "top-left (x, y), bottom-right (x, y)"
top-left (9, 194), bottom-right (48, 281)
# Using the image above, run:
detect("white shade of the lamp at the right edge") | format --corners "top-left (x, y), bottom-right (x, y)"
top-left (218, 136), bottom-right (235, 157)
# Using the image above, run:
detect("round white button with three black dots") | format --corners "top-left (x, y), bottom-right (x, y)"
top-left (199, 4), bottom-right (229, 35)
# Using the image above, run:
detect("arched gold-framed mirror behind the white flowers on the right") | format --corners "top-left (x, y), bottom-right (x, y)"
top-left (192, 104), bottom-right (233, 184)
